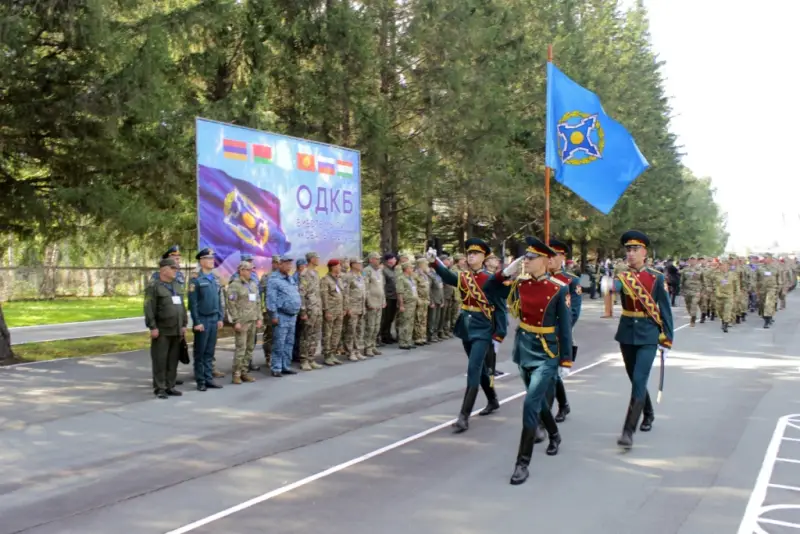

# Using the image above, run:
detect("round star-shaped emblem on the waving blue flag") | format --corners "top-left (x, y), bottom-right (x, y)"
top-left (556, 111), bottom-right (606, 165)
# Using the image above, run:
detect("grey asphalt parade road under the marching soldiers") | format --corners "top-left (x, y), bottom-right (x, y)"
top-left (0, 295), bottom-right (800, 534)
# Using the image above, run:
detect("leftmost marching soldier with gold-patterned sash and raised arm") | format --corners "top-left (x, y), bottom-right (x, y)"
top-left (427, 238), bottom-right (508, 433)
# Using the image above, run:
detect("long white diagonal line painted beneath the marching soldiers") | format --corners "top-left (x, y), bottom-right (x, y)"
top-left (161, 355), bottom-right (616, 534)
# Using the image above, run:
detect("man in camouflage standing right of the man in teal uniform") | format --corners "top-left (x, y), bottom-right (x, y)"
top-left (227, 261), bottom-right (262, 384)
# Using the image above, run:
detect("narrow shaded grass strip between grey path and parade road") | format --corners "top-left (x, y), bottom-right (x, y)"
top-left (3, 326), bottom-right (233, 364)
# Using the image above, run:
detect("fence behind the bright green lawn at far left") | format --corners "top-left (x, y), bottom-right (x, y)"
top-left (0, 267), bottom-right (194, 301)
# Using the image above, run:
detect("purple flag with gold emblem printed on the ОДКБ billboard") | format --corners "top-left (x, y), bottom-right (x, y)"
top-left (197, 165), bottom-right (291, 261)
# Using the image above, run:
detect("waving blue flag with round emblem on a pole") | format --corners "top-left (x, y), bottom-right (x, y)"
top-left (546, 63), bottom-right (650, 214)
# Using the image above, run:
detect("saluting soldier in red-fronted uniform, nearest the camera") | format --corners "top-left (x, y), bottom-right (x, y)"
top-left (485, 237), bottom-right (573, 485)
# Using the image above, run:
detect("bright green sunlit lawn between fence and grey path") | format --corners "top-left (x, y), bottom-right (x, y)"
top-left (3, 297), bottom-right (144, 328)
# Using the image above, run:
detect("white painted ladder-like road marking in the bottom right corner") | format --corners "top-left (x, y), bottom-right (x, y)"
top-left (737, 414), bottom-right (800, 534)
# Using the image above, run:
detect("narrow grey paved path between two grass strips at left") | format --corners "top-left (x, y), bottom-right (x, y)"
top-left (9, 317), bottom-right (147, 345)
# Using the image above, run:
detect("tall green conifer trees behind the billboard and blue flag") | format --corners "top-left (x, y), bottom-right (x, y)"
top-left (0, 0), bottom-right (727, 261)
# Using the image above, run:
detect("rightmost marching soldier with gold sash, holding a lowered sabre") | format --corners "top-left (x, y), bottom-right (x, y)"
top-left (614, 230), bottom-right (674, 449)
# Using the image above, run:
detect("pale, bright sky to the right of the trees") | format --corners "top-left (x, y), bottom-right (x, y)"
top-left (636, 0), bottom-right (800, 252)
